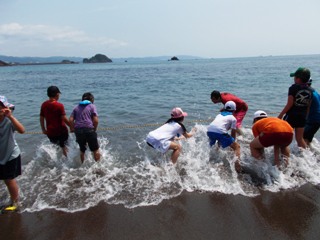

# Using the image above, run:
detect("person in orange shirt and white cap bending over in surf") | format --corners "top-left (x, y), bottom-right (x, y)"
top-left (250, 110), bottom-right (293, 168)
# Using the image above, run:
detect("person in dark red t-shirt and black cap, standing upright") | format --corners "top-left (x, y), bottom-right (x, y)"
top-left (40, 86), bottom-right (70, 156)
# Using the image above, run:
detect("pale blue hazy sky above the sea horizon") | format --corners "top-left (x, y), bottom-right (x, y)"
top-left (0, 0), bottom-right (320, 58)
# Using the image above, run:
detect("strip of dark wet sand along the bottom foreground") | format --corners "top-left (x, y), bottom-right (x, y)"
top-left (0, 184), bottom-right (320, 240)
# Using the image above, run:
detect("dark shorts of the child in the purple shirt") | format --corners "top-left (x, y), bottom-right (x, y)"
top-left (75, 128), bottom-right (99, 152)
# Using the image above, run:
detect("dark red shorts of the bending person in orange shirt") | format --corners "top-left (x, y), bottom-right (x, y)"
top-left (259, 133), bottom-right (293, 147)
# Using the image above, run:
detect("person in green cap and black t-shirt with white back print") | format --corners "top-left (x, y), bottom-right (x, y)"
top-left (278, 68), bottom-right (312, 148)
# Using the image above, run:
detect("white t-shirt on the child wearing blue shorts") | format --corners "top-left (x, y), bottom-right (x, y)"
top-left (208, 113), bottom-right (237, 134)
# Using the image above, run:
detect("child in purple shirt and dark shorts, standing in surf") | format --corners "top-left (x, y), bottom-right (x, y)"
top-left (69, 92), bottom-right (100, 163)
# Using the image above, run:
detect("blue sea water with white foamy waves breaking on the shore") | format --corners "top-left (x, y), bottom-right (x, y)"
top-left (0, 55), bottom-right (320, 212)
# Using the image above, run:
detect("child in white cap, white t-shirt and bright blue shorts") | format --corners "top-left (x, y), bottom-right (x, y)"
top-left (207, 101), bottom-right (241, 172)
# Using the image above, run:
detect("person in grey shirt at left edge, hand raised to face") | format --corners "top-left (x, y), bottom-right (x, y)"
top-left (0, 96), bottom-right (24, 211)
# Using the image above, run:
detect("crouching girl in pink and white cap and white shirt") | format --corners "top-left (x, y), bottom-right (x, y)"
top-left (146, 107), bottom-right (196, 163)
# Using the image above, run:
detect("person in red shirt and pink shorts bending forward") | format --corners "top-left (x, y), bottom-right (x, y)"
top-left (211, 90), bottom-right (248, 135)
